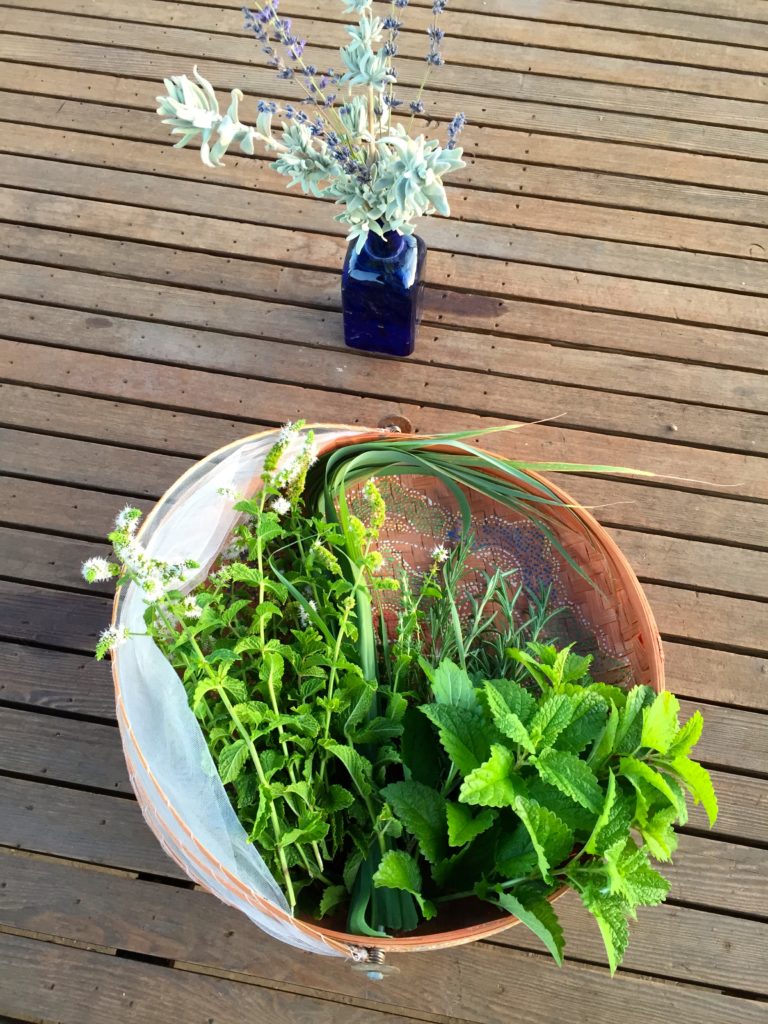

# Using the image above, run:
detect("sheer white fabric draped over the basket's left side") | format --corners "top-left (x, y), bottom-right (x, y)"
top-left (114, 429), bottom-right (358, 956)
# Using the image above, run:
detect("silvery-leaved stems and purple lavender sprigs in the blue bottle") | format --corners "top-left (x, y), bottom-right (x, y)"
top-left (158, 0), bottom-right (465, 250)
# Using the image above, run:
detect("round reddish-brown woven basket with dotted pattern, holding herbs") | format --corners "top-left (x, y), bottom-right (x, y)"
top-left (114, 423), bottom-right (664, 959)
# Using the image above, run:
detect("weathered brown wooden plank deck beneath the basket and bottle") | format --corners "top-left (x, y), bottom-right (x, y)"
top-left (0, 0), bottom-right (768, 1024)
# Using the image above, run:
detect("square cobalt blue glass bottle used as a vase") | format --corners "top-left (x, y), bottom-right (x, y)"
top-left (341, 231), bottom-right (427, 355)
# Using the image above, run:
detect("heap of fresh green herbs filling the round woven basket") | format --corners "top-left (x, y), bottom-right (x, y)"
top-left (84, 425), bottom-right (717, 970)
